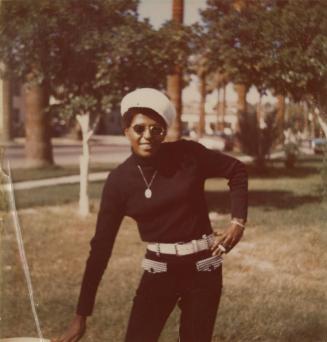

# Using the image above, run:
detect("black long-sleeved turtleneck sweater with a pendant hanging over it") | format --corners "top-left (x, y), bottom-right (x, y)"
top-left (77, 140), bottom-right (247, 316)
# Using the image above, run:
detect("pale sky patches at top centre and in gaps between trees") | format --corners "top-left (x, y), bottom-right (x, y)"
top-left (139, 0), bottom-right (275, 108)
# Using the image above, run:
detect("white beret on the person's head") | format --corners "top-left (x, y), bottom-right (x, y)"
top-left (120, 88), bottom-right (176, 127)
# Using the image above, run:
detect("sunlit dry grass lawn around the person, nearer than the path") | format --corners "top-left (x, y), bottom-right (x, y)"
top-left (0, 162), bottom-right (327, 342)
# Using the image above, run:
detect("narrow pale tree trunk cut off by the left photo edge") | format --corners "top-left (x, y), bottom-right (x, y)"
top-left (0, 79), bottom-right (12, 142)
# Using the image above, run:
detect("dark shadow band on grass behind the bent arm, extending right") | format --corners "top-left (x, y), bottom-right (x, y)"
top-left (206, 190), bottom-right (321, 213)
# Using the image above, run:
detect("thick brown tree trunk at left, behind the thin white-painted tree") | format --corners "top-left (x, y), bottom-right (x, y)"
top-left (23, 77), bottom-right (54, 167)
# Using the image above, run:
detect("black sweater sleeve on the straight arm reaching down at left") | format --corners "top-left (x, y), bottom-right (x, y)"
top-left (76, 171), bottom-right (124, 316)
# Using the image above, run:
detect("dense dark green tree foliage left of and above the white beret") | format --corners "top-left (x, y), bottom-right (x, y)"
top-left (0, 0), bottom-right (192, 120)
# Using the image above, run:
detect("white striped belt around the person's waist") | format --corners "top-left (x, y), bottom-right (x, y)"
top-left (147, 234), bottom-right (215, 255)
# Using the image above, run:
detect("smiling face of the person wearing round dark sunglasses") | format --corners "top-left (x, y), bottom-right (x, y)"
top-left (124, 113), bottom-right (166, 157)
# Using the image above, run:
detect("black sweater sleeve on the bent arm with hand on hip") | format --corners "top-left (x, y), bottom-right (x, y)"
top-left (189, 141), bottom-right (248, 221)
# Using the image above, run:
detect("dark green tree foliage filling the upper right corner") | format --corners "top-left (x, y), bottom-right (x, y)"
top-left (202, 0), bottom-right (327, 101)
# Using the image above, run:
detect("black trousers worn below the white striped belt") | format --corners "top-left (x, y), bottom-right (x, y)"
top-left (125, 251), bottom-right (222, 342)
